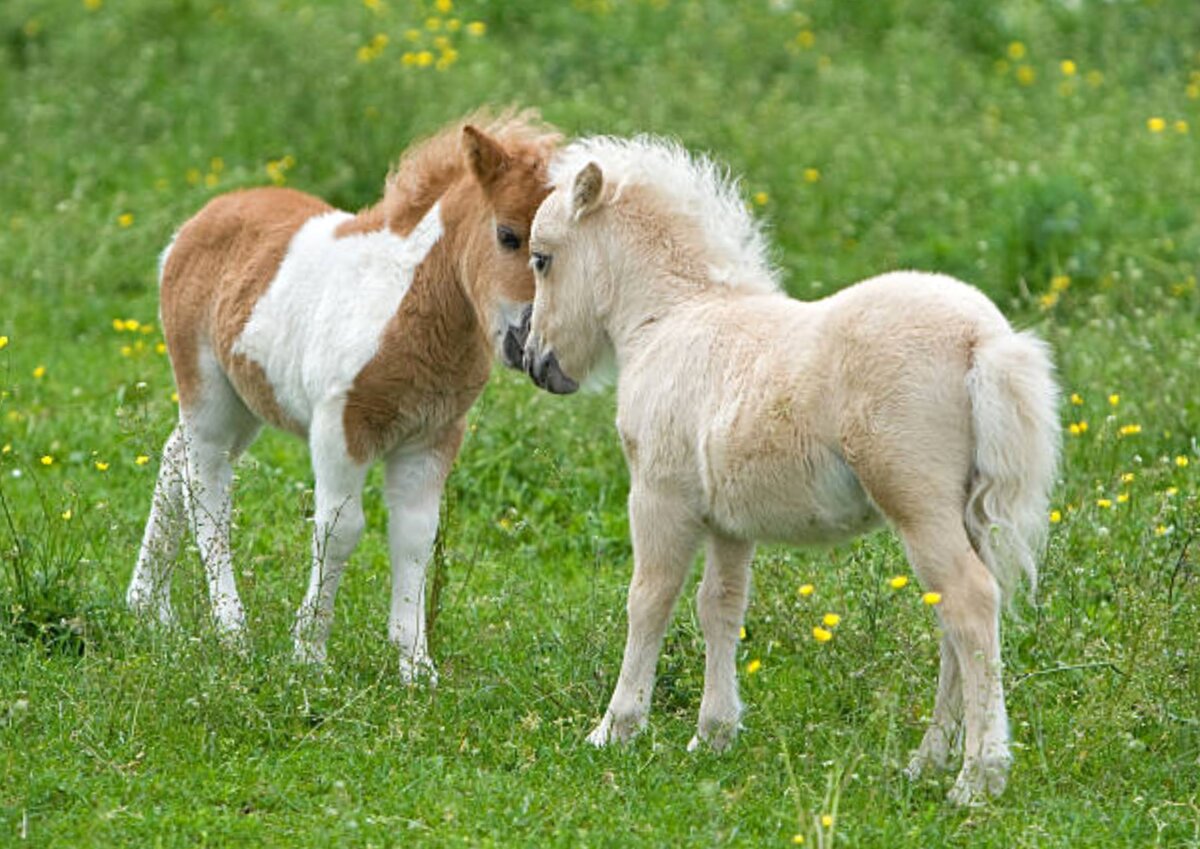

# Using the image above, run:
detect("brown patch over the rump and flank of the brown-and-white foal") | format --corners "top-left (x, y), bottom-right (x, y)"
top-left (161, 188), bottom-right (332, 434)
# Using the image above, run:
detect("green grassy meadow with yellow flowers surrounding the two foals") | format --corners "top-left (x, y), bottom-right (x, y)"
top-left (0, 0), bottom-right (1200, 847)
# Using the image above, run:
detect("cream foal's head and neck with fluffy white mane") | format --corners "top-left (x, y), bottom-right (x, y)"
top-left (524, 137), bottom-right (778, 393)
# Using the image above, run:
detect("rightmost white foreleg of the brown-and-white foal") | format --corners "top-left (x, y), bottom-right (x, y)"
top-left (384, 439), bottom-right (458, 684)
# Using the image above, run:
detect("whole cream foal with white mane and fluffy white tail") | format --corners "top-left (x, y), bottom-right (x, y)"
top-left (526, 138), bottom-right (1060, 803)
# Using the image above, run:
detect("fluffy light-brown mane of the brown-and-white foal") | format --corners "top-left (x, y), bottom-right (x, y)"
top-left (337, 107), bottom-right (563, 236)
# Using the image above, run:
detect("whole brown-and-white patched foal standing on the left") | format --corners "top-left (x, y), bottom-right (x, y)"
top-left (127, 113), bottom-right (560, 680)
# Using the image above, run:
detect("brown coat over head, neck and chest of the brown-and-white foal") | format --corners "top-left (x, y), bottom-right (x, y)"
top-left (338, 112), bottom-right (559, 462)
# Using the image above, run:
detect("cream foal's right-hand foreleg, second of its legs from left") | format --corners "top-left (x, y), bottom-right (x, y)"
top-left (688, 535), bottom-right (754, 752)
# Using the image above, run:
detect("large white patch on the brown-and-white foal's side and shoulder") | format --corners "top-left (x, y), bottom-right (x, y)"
top-left (232, 204), bottom-right (443, 427)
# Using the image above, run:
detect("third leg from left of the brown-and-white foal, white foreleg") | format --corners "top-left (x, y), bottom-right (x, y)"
top-left (292, 403), bottom-right (371, 664)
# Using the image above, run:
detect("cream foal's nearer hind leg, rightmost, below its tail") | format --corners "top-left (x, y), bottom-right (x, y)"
top-left (901, 522), bottom-right (1012, 805)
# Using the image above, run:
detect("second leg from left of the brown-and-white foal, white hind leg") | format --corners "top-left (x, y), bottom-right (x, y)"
top-left (181, 372), bottom-right (260, 636)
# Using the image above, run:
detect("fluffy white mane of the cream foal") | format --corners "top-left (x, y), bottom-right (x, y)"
top-left (550, 136), bottom-right (780, 291)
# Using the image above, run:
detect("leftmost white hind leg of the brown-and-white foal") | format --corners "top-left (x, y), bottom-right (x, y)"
top-left (125, 427), bottom-right (185, 625)
